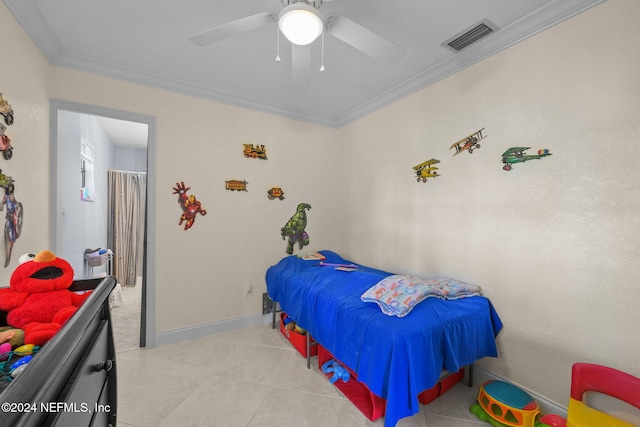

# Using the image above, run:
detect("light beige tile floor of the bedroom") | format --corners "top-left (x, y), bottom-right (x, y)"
top-left (112, 286), bottom-right (489, 427)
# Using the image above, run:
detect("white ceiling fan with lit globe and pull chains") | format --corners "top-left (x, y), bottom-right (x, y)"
top-left (189, 0), bottom-right (404, 83)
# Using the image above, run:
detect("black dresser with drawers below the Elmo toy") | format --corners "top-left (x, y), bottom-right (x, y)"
top-left (0, 277), bottom-right (117, 427)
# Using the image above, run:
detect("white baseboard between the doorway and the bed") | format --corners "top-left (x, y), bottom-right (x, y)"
top-left (155, 314), bottom-right (271, 346)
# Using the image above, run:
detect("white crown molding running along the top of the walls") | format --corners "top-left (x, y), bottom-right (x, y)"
top-left (3, 0), bottom-right (606, 128)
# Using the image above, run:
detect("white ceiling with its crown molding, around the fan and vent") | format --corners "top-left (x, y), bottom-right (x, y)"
top-left (3, 0), bottom-right (603, 131)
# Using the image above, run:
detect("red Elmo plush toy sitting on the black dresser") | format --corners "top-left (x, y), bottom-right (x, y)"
top-left (0, 250), bottom-right (89, 345)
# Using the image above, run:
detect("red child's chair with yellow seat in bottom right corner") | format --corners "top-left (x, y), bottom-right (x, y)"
top-left (567, 363), bottom-right (640, 427)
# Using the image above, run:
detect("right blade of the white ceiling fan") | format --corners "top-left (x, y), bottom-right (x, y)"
top-left (327, 15), bottom-right (404, 61)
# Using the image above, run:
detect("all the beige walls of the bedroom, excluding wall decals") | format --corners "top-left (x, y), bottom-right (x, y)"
top-left (0, 0), bottom-right (640, 412)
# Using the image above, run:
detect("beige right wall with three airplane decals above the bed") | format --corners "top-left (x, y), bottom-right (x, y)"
top-left (340, 0), bottom-right (640, 405)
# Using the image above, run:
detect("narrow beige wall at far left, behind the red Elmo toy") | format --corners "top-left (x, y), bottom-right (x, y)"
top-left (0, 0), bottom-right (50, 278)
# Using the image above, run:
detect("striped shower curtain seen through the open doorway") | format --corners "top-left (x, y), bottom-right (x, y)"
top-left (107, 170), bottom-right (147, 286)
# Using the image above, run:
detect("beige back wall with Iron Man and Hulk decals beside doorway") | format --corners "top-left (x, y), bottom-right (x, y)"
top-left (51, 68), bottom-right (341, 332)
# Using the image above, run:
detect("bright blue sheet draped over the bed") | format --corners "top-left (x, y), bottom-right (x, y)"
top-left (266, 250), bottom-right (502, 427)
